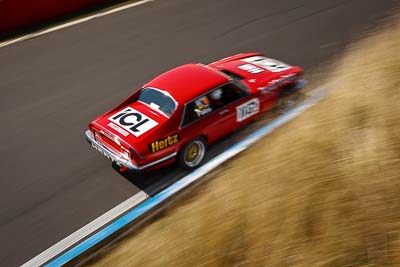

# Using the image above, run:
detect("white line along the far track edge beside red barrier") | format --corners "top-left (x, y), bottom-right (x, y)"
top-left (0, 0), bottom-right (155, 48)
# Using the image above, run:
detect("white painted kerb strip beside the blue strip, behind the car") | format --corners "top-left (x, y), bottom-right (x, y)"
top-left (21, 191), bottom-right (149, 267)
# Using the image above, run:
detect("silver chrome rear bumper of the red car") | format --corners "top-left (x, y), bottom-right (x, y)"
top-left (85, 130), bottom-right (177, 171)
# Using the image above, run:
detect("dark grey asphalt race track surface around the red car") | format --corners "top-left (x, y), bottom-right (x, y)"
top-left (0, 0), bottom-right (399, 266)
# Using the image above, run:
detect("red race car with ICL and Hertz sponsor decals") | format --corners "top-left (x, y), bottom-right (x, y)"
top-left (85, 53), bottom-right (304, 171)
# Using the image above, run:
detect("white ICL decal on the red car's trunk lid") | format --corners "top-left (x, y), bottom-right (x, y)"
top-left (108, 107), bottom-right (158, 137)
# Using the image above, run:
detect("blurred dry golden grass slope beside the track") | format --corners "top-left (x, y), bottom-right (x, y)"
top-left (90, 17), bottom-right (400, 266)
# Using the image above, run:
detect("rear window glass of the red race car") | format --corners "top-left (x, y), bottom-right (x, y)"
top-left (138, 88), bottom-right (177, 116)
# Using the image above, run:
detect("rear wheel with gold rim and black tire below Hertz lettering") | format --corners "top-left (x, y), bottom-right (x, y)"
top-left (178, 138), bottom-right (207, 170)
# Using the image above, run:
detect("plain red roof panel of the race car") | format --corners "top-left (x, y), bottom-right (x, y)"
top-left (145, 64), bottom-right (230, 104)
